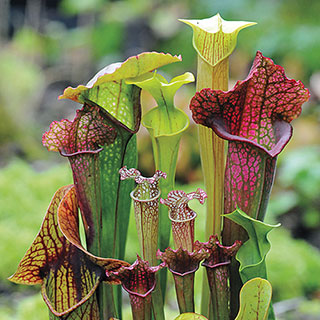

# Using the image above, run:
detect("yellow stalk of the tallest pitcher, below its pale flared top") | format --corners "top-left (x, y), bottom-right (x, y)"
top-left (197, 56), bottom-right (229, 315)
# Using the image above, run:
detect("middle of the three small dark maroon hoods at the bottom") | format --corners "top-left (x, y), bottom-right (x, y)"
top-left (157, 248), bottom-right (209, 276)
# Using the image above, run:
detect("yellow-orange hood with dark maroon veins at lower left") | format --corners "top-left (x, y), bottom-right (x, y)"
top-left (10, 185), bottom-right (128, 316)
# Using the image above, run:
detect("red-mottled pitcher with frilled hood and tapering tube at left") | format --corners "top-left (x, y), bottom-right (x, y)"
top-left (42, 104), bottom-right (116, 250)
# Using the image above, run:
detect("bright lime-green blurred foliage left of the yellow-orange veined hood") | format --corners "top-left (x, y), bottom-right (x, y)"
top-left (0, 160), bottom-right (72, 279)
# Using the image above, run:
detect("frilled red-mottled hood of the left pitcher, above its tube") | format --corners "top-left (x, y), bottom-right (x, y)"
top-left (42, 104), bottom-right (116, 154)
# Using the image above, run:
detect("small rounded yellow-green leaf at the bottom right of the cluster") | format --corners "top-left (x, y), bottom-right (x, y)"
top-left (235, 278), bottom-right (272, 320)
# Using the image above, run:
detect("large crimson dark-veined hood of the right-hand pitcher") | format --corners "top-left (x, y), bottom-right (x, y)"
top-left (190, 51), bottom-right (309, 150)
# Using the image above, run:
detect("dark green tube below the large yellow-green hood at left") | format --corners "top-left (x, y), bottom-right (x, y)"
top-left (100, 130), bottom-right (137, 317)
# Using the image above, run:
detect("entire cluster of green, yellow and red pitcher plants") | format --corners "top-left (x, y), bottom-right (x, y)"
top-left (10, 15), bottom-right (309, 320)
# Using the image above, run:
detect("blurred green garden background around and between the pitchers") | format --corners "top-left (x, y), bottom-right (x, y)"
top-left (0, 0), bottom-right (320, 320)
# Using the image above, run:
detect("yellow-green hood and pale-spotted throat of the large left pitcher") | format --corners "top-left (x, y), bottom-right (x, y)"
top-left (60, 52), bottom-right (181, 131)
